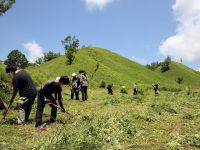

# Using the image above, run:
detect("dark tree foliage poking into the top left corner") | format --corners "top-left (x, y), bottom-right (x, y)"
top-left (0, 0), bottom-right (15, 16)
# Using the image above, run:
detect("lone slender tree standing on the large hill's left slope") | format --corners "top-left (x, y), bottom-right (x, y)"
top-left (62, 36), bottom-right (79, 65)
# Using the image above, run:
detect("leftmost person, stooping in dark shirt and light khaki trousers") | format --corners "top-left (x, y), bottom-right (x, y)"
top-left (6, 65), bottom-right (37, 124)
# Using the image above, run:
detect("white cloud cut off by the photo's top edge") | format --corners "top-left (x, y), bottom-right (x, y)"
top-left (82, 0), bottom-right (119, 11)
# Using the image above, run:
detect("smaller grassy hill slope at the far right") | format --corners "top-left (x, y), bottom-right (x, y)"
top-left (156, 62), bottom-right (200, 86)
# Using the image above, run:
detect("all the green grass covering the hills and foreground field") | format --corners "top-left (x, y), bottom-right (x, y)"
top-left (0, 47), bottom-right (200, 150)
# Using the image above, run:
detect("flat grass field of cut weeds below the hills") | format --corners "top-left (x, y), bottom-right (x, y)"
top-left (0, 86), bottom-right (200, 149)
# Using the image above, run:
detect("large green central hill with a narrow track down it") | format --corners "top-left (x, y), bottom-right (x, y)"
top-left (29, 47), bottom-right (176, 87)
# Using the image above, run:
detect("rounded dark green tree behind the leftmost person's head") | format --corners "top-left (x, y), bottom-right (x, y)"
top-left (4, 50), bottom-right (28, 69)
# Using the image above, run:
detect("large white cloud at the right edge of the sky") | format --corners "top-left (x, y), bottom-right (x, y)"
top-left (159, 0), bottom-right (200, 62)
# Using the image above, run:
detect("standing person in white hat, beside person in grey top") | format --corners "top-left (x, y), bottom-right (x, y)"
top-left (71, 73), bottom-right (80, 100)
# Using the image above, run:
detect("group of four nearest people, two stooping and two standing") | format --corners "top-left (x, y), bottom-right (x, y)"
top-left (4, 65), bottom-right (88, 129)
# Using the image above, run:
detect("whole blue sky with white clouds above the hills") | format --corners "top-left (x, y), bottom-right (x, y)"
top-left (0, 0), bottom-right (200, 69)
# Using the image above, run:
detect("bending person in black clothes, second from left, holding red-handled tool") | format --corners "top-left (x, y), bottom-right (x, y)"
top-left (35, 76), bottom-right (69, 128)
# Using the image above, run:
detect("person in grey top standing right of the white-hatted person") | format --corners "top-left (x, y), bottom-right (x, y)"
top-left (79, 70), bottom-right (89, 101)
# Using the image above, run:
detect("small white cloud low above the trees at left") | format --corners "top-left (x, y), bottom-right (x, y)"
top-left (23, 41), bottom-right (44, 63)
